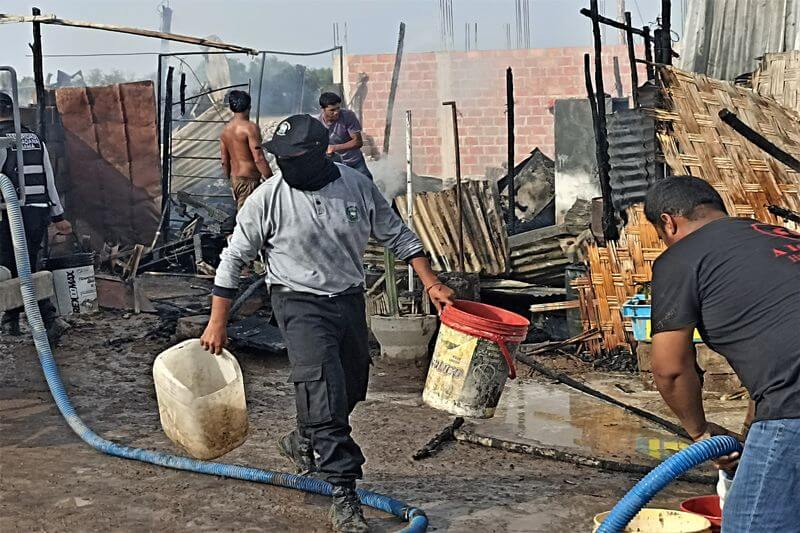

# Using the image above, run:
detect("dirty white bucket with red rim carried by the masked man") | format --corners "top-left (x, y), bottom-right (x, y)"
top-left (422, 300), bottom-right (530, 418)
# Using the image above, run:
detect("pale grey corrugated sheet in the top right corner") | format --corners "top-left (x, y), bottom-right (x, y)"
top-left (676, 0), bottom-right (800, 80)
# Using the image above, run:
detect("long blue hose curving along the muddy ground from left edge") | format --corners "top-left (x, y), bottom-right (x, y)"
top-left (0, 174), bottom-right (428, 533)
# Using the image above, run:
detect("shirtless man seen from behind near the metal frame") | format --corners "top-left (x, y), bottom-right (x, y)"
top-left (219, 91), bottom-right (272, 211)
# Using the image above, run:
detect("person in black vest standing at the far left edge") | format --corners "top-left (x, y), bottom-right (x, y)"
top-left (0, 92), bottom-right (72, 341)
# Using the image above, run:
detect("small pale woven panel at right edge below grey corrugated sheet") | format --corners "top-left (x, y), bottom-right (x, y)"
top-left (753, 50), bottom-right (800, 114)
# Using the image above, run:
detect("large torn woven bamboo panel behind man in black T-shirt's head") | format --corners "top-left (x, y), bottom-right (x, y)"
top-left (573, 68), bottom-right (800, 349)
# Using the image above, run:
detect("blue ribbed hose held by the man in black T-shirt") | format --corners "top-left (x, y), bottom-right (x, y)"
top-left (597, 436), bottom-right (742, 533)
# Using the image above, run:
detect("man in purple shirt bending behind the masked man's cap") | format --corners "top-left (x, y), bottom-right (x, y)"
top-left (317, 93), bottom-right (372, 179)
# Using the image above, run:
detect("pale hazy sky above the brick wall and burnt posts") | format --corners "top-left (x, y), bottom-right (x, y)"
top-left (0, 0), bottom-right (684, 77)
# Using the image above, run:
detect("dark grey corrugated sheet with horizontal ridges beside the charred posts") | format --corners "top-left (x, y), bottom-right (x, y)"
top-left (608, 109), bottom-right (656, 211)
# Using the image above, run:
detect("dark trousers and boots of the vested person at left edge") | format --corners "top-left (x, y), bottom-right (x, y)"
top-left (0, 207), bottom-right (56, 326)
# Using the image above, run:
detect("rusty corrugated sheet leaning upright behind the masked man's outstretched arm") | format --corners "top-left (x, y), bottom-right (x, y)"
top-left (396, 181), bottom-right (508, 276)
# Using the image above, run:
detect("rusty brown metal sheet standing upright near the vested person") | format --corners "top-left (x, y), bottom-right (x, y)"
top-left (55, 81), bottom-right (161, 249)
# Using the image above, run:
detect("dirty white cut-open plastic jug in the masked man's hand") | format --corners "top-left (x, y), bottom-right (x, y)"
top-left (153, 339), bottom-right (248, 459)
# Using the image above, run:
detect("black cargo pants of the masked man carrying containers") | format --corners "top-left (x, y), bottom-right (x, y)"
top-left (272, 287), bottom-right (371, 485)
